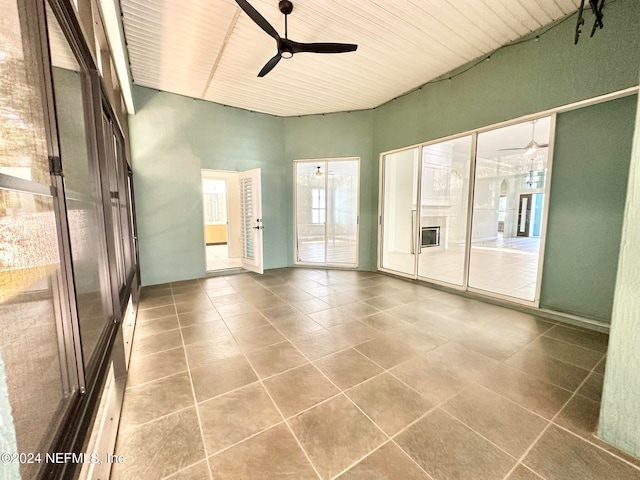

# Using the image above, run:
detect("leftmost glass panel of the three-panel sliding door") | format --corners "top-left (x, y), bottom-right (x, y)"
top-left (381, 148), bottom-right (420, 276)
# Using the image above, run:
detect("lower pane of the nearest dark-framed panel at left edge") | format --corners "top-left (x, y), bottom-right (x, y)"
top-left (0, 189), bottom-right (71, 478)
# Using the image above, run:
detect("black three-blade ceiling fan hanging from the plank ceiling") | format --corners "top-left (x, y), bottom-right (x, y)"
top-left (236, 0), bottom-right (358, 77)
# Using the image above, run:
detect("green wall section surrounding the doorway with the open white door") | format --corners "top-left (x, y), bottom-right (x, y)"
top-left (130, 87), bottom-right (284, 285)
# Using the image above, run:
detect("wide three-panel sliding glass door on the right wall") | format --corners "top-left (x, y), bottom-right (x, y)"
top-left (379, 117), bottom-right (553, 302)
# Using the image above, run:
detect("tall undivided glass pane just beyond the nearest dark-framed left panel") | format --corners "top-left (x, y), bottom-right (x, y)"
top-left (47, 10), bottom-right (112, 372)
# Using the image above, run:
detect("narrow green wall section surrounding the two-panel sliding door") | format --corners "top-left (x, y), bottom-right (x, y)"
top-left (284, 110), bottom-right (378, 270)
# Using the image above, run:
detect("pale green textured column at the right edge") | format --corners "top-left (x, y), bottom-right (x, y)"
top-left (598, 77), bottom-right (640, 458)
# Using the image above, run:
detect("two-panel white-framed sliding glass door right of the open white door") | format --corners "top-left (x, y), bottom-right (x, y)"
top-left (294, 158), bottom-right (360, 267)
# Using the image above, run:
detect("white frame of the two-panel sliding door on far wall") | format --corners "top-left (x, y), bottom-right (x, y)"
top-left (293, 157), bottom-right (361, 269)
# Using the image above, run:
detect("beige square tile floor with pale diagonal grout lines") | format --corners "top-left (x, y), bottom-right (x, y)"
top-left (111, 268), bottom-right (640, 480)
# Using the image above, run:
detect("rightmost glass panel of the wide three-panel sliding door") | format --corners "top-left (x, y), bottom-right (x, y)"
top-left (469, 117), bottom-right (551, 301)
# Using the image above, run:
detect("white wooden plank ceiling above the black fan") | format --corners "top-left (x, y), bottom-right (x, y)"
top-left (121, 0), bottom-right (579, 116)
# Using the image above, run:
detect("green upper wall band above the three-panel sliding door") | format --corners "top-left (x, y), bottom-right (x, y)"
top-left (374, 0), bottom-right (640, 155)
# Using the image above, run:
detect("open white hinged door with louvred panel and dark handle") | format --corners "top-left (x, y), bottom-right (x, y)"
top-left (238, 168), bottom-right (264, 273)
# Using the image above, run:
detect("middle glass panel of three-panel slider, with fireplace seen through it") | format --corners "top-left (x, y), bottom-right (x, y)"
top-left (418, 136), bottom-right (472, 286)
